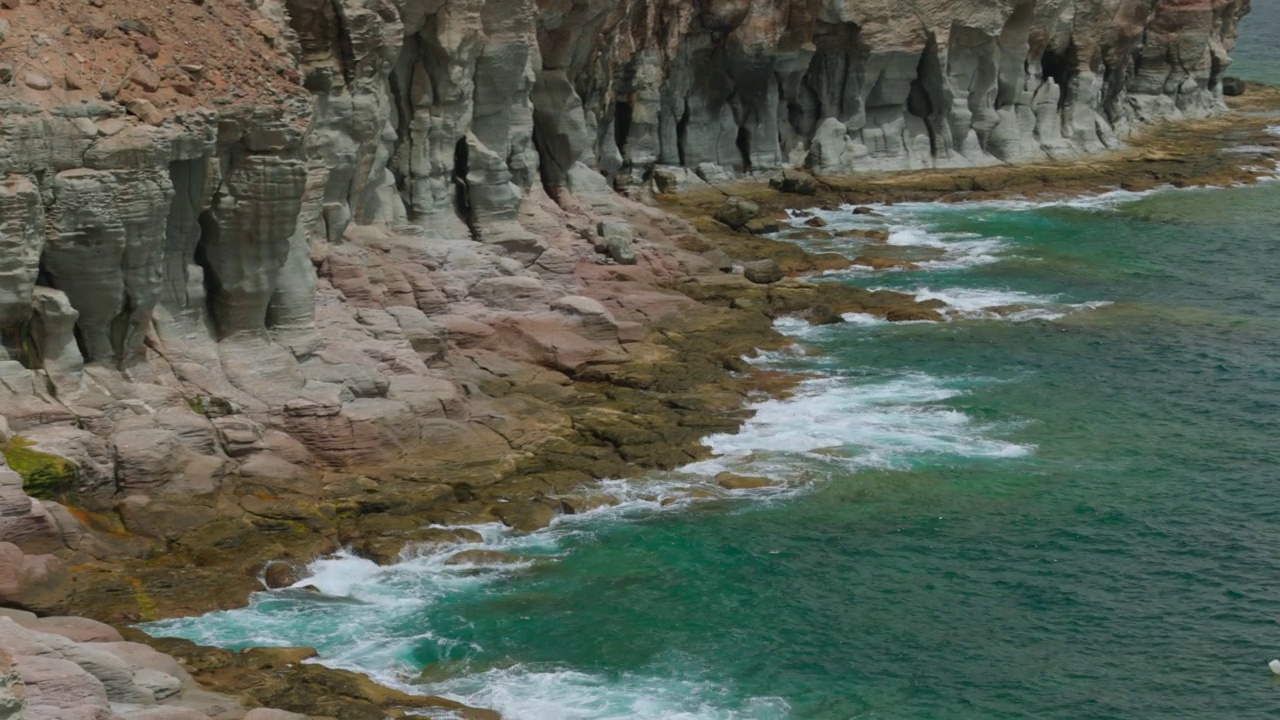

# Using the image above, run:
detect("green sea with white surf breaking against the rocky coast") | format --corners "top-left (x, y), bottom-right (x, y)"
top-left (145, 9), bottom-right (1280, 720)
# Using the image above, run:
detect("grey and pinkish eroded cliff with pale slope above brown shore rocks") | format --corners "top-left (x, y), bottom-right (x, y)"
top-left (0, 0), bottom-right (1249, 600)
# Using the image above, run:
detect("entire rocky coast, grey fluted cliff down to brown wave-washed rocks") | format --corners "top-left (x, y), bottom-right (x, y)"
top-left (0, 0), bottom-right (1264, 720)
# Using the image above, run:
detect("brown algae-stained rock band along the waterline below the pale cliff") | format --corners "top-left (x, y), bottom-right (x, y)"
top-left (5, 88), bottom-right (1280, 720)
